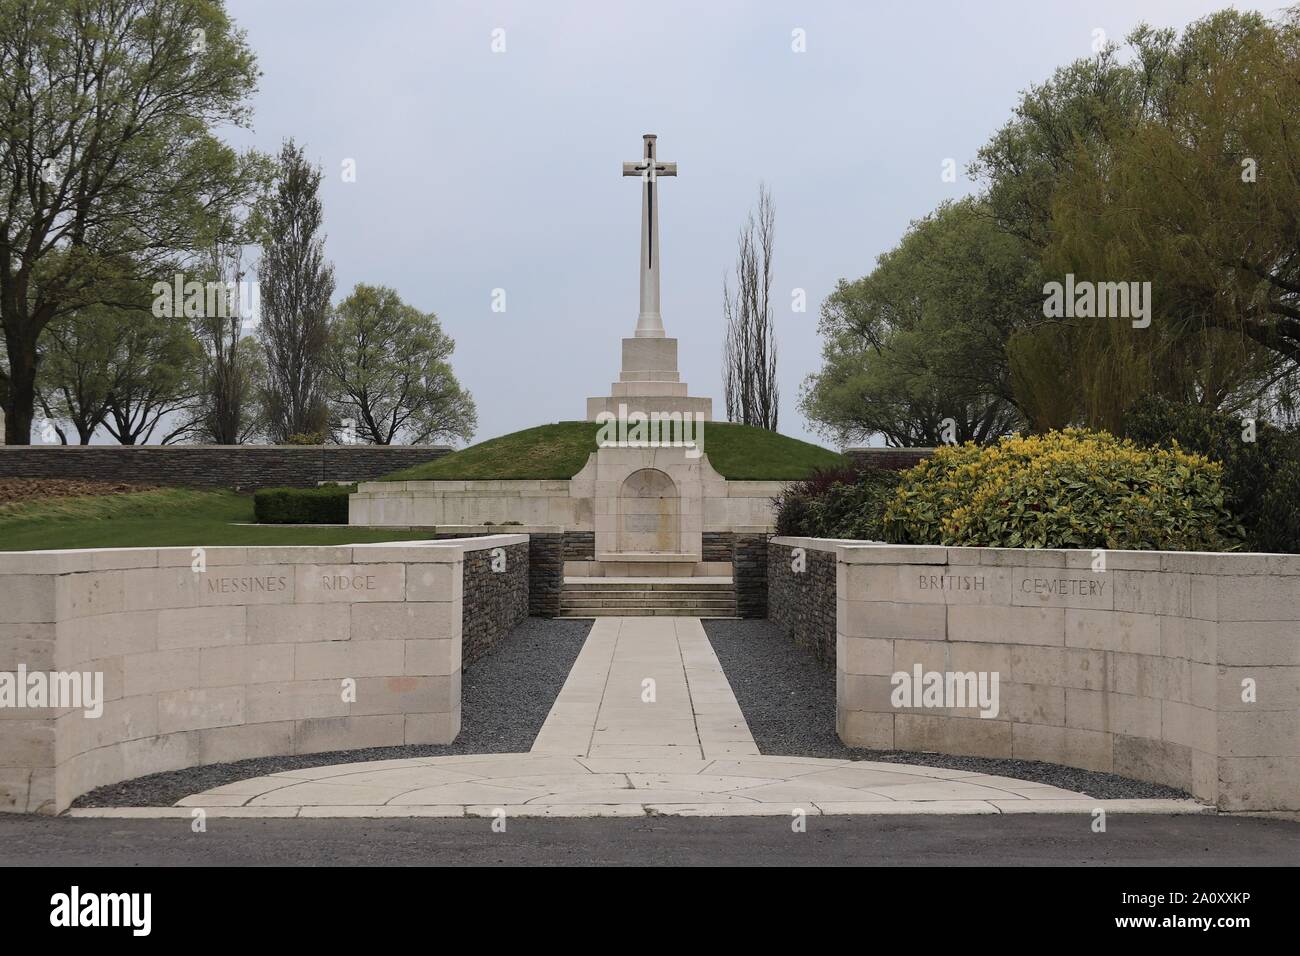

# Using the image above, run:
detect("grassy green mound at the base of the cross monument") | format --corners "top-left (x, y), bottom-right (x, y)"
top-left (382, 421), bottom-right (842, 481)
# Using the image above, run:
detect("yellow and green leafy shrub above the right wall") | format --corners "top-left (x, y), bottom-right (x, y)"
top-left (884, 428), bottom-right (1242, 551)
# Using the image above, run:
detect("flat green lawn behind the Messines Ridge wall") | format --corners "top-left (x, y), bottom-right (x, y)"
top-left (0, 488), bottom-right (439, 551)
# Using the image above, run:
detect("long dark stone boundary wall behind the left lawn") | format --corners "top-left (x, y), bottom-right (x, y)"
top-left (0, 445), bottom-right (451, 490)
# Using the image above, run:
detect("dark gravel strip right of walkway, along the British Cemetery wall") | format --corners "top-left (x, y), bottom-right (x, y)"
top-left (705, 620), bottom-right (1187, 800)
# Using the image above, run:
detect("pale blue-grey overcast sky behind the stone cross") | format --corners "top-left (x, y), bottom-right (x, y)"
top-left (210, 0), bottom-right (1279, 440)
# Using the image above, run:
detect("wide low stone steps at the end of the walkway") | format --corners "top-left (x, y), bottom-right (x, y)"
top-left (559, 578), bottom-right (736, 618)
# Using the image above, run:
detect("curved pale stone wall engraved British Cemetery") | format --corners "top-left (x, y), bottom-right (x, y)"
top-left (772, 538), bottom-right (1300, 812)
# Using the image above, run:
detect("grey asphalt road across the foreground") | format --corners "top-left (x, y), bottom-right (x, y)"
top-left (0, 814), bottom-right (1300, 866)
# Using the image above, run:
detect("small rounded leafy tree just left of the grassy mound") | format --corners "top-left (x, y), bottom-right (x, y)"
top-left (326, 285), bottom-right (478, 445)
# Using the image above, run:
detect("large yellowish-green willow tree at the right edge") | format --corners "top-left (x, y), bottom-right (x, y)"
top-left (974, 9), bottom-right (1300, 429)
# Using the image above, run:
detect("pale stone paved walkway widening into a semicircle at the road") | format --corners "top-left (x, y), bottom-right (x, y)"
top-left (69, 618), bottom-right (1210, 817)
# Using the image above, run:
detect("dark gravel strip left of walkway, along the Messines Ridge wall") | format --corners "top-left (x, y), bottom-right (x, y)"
top-left (73, 618), bottom-right (592, 806)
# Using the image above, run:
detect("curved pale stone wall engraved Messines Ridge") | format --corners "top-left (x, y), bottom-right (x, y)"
top-left (0, 535), bottom-right (528, 813)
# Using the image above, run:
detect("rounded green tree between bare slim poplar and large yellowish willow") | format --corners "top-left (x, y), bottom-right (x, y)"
top-left (801, 199), bottom-right (1041, 446)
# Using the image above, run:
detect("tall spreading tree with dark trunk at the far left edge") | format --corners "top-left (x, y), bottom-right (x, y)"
top-left (0, 0), bottom-right (263, 445)
